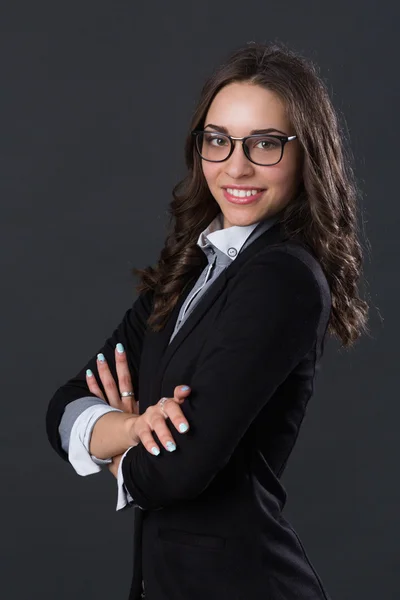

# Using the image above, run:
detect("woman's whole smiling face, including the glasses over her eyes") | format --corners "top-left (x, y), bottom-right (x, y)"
top-left (196, 81), bottom-right (303, 227)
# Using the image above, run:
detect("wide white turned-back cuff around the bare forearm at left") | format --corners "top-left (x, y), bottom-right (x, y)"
top-left (68, 405), bottom-right (123, 475)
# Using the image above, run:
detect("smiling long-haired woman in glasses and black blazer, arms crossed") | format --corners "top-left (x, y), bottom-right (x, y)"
top-left (47, 43), bottom-right (368, 600)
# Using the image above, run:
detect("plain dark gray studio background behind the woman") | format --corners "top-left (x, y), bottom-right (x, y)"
top-left (0, 0), bottom-right (400, 600)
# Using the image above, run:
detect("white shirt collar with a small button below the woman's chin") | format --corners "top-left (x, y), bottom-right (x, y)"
top-left (197, 212), bottom-right (278, 260)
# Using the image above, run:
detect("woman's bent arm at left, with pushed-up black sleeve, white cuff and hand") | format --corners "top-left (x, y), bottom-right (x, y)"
top-left (47, 286), bottom-right (190, 488)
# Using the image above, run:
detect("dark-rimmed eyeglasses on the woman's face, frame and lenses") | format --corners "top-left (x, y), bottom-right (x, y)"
top-left (191, 129), bottom-right (297, 167)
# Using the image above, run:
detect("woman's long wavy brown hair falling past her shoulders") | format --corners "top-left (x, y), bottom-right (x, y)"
top-left (132, 42), bottom-right (368, 346)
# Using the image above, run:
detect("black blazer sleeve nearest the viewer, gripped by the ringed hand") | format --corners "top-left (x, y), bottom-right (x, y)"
top-left (122, 250), bottom-right (323, 510)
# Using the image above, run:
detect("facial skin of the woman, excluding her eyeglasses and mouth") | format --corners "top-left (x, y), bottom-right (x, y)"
top-left (201, 82), bottom-right (302, 229)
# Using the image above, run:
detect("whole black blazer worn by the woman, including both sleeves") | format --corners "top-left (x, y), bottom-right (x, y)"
top-left (47, 222), bottom-right (331, 600)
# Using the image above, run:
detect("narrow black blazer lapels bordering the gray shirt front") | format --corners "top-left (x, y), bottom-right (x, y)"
top-left (151, 221), bottom-right (284, 394)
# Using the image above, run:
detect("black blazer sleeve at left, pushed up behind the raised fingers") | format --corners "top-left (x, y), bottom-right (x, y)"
top-left (46, 291), bottom-right (153, 461)
